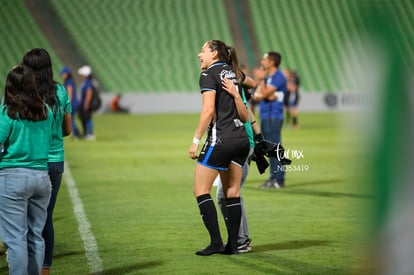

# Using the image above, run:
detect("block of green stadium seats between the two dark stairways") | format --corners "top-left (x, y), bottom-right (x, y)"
top-left (51, 0), bottom-right (231, 92)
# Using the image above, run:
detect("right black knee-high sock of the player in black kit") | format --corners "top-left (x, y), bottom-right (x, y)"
top-left (226, 197), bottom-right (241, 254)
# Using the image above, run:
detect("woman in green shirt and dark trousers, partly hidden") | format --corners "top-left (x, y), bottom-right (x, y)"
top-left (23, 48), bottom-right (72, 275)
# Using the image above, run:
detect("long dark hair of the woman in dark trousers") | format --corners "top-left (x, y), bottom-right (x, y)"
top-left (23, 48), bottom-right (56, 109)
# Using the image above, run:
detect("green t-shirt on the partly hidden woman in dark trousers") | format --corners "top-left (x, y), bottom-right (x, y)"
top-left (49, 84), bottom-right (72, 162)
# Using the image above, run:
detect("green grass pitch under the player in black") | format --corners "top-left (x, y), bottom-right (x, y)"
top-left (0, 112), bottom-right (375, 275)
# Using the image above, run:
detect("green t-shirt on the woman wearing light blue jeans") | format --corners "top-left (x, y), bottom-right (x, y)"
top-left (0, 105), bottom-right (53, 170)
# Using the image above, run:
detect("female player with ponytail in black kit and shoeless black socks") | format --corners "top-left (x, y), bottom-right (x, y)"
top-left (189, 40), bottom-right (250, 256)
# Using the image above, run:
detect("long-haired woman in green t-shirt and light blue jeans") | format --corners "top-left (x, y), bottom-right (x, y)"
top-left (0, 65), bottom-right (53, 274)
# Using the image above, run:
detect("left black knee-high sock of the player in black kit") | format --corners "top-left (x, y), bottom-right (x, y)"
top-left (197, 194), bottom-right (223, 247)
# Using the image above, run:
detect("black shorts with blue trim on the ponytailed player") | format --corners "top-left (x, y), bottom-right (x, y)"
top-left (197, 137), bottom-right (250, 170)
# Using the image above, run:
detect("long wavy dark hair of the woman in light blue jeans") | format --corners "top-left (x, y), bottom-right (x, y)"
top-left (3, 64), bottom-right (47, 121)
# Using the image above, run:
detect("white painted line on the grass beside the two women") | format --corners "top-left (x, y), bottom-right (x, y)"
top-left (63, 161), bottom-right (103, 274)
